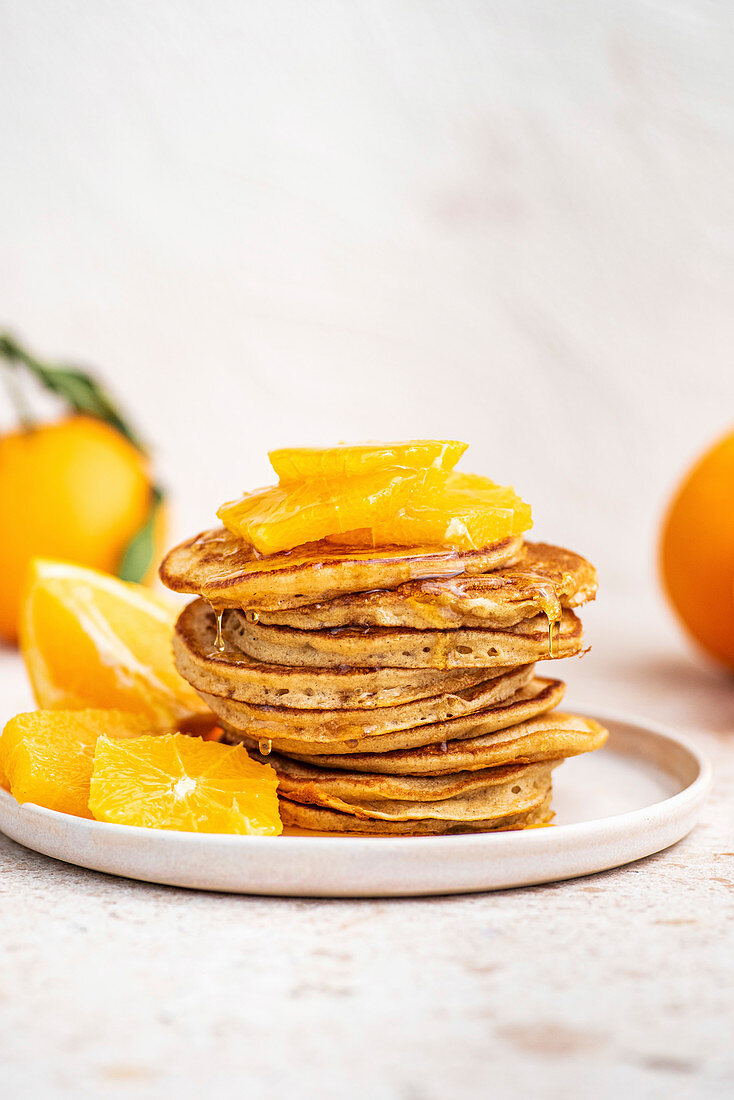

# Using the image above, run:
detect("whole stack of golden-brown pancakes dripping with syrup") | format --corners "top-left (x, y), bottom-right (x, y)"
top-left (161, 528), bottom-right (606, 835)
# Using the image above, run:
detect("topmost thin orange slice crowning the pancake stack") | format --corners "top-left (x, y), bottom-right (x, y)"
top-left (269, 439), bottom-right (469, 484)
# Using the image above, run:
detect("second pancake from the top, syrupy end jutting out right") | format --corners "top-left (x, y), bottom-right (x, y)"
top-left (259, 542), bottom-right (596, 630)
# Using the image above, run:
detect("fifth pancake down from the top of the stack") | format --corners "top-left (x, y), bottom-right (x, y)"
top-left (192, 664), bottom-right (533, 738)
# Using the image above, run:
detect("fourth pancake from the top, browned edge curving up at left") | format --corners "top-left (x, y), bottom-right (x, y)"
top-left (173, 600), bottom-right (493, 713)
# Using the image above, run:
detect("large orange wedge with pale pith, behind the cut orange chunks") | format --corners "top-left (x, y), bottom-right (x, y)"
top-left (21, 559), bottom-right (213, 728)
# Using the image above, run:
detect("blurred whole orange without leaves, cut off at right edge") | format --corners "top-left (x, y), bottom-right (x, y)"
top-left (660, 431), bottom-right (734, 669)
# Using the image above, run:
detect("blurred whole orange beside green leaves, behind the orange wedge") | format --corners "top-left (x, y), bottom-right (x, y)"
top-left (0, 415), bottom-right (159, 641)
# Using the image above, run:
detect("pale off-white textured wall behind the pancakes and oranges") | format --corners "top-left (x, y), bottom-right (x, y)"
top-left (0, 0), bottom-right (734, 607)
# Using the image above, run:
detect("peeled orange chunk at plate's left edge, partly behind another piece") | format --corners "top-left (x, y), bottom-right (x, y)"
top-left (0, 711), bottom-right (150, 817)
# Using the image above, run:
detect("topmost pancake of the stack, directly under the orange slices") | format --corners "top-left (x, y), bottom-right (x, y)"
top-left (158, 527), bottom-right (523, 611)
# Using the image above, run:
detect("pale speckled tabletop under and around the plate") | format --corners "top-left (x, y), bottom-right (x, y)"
top-left (0, 609), bottom-right (734, 1100)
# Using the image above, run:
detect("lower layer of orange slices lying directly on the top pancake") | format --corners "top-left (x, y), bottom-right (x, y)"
top-left (217, 441), bottom-right (533, 556)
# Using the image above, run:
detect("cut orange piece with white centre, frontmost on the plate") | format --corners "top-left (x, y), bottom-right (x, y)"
top-left (89, 734), bottom-right (283, 836)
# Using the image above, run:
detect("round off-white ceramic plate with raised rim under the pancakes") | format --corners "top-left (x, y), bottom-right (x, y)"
top-left (0, 714), bottom-right (711, 898)
